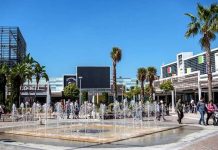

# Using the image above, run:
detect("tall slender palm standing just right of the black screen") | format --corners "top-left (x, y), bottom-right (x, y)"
top-left (111, 47), bottom-right (122, 100)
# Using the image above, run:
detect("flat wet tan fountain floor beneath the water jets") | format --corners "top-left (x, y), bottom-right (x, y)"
top-left (5, 123), bottom-right (182, 143)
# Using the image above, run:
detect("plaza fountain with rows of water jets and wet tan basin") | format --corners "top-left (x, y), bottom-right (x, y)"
top-left (7, 99), bottom-right (182, 143)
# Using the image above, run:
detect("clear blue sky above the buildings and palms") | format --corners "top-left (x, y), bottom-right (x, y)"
top-left (0, 0), bottom-right (218, 78)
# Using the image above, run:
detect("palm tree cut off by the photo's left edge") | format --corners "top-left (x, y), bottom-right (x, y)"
top-left (0, 64), bottom-right (9, 105)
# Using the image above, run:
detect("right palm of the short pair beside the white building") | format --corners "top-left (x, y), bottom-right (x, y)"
top-left (147, 67), bottom-right (157, 100)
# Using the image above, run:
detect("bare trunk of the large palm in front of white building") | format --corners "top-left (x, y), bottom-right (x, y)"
top-left (205, 43), bottom-right (212, 101)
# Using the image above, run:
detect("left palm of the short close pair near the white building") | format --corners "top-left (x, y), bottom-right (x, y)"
top-left (137, 68), bottom-right (147, 101)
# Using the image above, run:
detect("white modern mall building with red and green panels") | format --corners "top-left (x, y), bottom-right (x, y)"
top-left (154, 48), bottom-right (218, 103)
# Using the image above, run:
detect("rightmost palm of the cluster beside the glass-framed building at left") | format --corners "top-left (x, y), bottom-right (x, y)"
top-left (34, 63), bottom-right (49, 100)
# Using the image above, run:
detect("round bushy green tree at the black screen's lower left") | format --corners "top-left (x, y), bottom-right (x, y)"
top-left (64, 83), bottom-right (79, 101)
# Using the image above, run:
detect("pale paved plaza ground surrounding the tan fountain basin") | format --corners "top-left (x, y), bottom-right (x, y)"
top-left (0, 113), bottom-right (218, 150)
